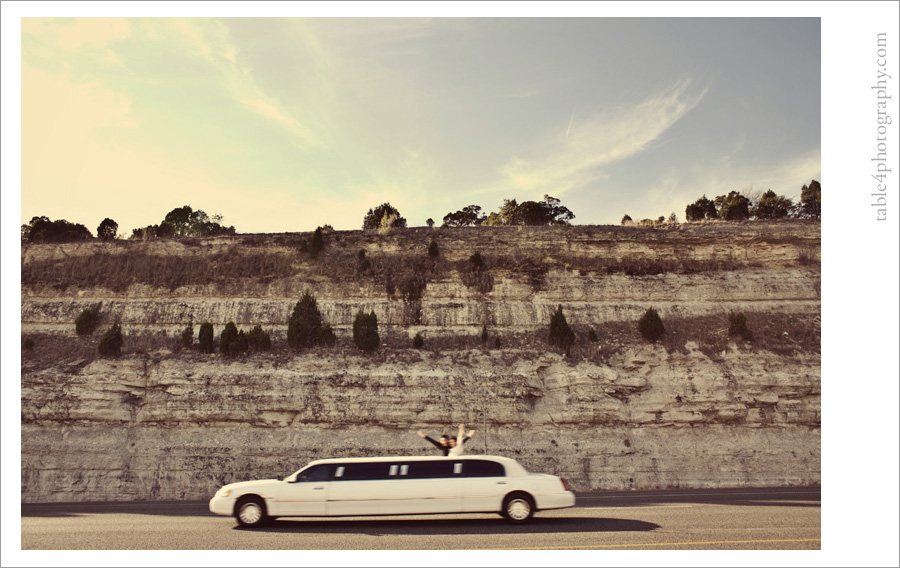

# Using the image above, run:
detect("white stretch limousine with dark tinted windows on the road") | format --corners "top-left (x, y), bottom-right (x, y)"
top-left (209, 455), bottom-right (575, 527)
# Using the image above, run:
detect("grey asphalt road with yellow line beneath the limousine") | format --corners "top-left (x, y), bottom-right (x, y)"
top-left (21, 488), bottom-right (822, 551)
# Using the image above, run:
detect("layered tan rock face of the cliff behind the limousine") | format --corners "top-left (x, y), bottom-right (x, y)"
top-left (22, 222), bottom-right (821, 502)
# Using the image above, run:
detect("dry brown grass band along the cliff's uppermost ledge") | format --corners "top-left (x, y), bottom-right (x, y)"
top-left (21, 221), bottom-right (817, 292)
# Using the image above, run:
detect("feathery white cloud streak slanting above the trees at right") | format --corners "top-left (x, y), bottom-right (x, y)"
top-left (490, 79), bottom-right (708, 196)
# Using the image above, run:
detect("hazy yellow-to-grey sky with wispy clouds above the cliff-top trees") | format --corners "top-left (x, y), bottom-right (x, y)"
top-left (21, 17), bottom-right (828, 235)
